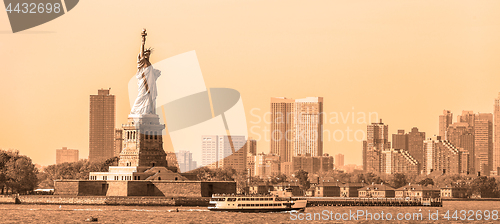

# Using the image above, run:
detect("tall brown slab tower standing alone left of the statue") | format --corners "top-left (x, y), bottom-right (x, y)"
top-left (89, 89), bottom-right (116, 162)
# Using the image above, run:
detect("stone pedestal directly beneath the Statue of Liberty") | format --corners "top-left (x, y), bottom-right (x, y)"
top-left (118, 114), bottom-right (167, 167)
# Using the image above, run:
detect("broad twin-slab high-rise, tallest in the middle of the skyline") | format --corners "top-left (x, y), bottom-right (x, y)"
top-left (271, 97), bottom-right (323, 174)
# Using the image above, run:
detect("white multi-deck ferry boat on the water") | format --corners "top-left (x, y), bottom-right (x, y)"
top-left (208, 195), bottom-right (307, 212)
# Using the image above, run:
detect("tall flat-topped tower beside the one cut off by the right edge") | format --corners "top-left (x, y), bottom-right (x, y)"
top-left (474, 113), bottom-right (493, 175)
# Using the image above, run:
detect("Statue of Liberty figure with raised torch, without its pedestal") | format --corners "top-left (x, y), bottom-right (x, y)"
top-left (130, 29), bottom-right (161, 115)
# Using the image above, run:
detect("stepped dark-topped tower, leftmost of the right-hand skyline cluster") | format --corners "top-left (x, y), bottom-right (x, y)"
top-left (363, 119), bottom-right (391, 173)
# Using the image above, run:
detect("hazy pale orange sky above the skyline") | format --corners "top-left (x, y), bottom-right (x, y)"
top-left (0, 0), bottom-right (500, 165)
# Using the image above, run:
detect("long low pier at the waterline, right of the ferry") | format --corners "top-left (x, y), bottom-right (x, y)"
top-left (297, 197), bottom-right (443, 207)
